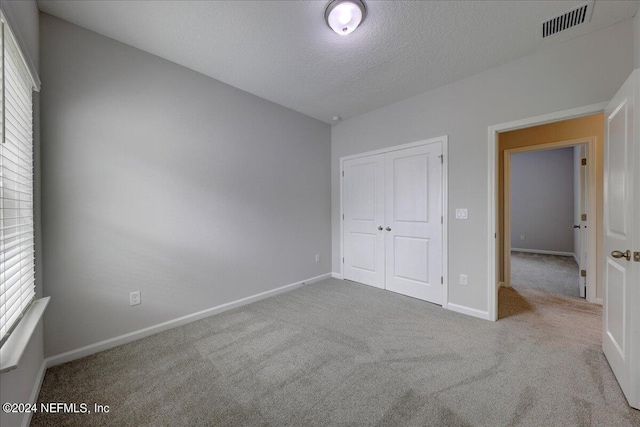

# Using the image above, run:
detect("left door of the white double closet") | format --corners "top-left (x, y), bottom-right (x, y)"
top-left (342, 154), bottom-right (385, 289)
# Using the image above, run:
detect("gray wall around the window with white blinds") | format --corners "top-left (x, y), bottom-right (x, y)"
top-left (0, 0), bottom-right (44, 426)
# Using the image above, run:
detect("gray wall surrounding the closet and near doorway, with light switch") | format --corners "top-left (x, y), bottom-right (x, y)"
top-left (331, 19), bottom-right (634, 311)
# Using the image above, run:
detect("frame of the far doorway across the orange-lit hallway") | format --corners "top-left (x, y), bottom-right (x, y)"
top-left (502, 136), bottom-right (598, 302)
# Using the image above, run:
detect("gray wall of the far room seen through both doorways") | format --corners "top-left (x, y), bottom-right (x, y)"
top-left (511, 147), bottom-right (574, 253)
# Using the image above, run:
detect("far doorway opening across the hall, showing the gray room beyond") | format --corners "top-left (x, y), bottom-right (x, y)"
top-left (508, 141), bottom-right (596, 298)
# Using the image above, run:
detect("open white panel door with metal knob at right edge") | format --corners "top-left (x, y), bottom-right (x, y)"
top-left (602, 69), bottom-right (640, 409)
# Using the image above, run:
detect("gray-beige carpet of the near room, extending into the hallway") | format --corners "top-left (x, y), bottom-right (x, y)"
top-left (32, 279), bottom-right (640, 427)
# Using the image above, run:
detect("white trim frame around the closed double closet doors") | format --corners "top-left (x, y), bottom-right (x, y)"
top-left (338, 135), bottom-right (449, 309)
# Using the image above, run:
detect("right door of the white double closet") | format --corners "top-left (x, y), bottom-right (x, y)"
top-left (384, 143), bottom-right (442, 304)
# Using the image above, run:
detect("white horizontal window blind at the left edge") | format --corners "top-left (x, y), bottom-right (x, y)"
top-left (0, 15), bottom-right (35, 348)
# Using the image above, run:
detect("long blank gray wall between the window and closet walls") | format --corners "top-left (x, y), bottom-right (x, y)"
top-left (40, 14), bottom-right (331, 356)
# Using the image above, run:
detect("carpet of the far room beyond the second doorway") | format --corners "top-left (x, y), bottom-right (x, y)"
top-left (511, 252), bottom-right (581, 298)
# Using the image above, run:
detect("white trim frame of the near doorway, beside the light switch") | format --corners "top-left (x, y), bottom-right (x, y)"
top-left (487, 102), bottom-right (607, 321)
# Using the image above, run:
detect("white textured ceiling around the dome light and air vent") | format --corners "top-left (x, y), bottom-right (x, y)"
top-left (38, 0), bottom-right (640, 123)
